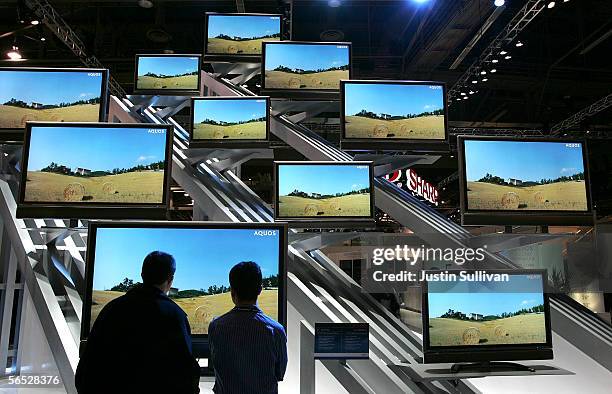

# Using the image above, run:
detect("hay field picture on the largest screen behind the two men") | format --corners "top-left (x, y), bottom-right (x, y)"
top-left (91, 228), bottom-right (279, 334)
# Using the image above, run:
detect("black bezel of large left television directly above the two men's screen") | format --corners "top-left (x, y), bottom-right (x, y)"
top-left (16, 122), bottom-right (174, 220)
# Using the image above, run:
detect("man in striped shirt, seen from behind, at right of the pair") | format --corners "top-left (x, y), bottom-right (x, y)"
top-left (208, 261), bottom-right (287, 394)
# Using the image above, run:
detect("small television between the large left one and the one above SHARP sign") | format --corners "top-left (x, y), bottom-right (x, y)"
top-left (189, 96), bottom-right (270, 148)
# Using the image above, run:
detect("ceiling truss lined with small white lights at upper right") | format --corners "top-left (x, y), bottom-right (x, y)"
top-left (448, 0), bottom-right (547, 105)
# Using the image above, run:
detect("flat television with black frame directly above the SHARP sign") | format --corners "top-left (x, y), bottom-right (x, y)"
top-left (340, 81), bottom-right (448, 150)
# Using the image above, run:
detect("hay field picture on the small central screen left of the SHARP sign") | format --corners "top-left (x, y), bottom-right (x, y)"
top-left (278, 164), bottom-right (372, 218)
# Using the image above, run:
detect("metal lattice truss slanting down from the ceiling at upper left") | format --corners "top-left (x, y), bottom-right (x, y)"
top-left (25, 0), bottom-right (127, 97)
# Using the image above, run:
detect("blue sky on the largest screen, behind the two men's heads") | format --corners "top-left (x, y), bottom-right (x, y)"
top-left (93, 228), bottom-right (279, 290)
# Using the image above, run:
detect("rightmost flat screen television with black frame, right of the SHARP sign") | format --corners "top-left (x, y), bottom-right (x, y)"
top-left (457, 136), bottom-right (593, 225)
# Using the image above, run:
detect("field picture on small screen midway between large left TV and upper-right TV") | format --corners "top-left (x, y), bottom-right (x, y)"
top-left (192, 99), bottom-right (267, 140)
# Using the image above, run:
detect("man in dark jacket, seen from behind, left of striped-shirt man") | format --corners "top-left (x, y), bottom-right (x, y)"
top-left (75, 252), bottom-right (200, 394)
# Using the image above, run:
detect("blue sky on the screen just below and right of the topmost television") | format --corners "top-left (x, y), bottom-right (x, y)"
top-left (266, 44), bottom-right (349, 70)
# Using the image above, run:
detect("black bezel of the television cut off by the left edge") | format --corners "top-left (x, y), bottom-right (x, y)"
top-left (0, 67), bottom-right (109, 141)
